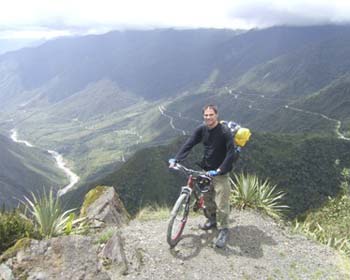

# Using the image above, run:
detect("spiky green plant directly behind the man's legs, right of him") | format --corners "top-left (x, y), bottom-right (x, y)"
top-left (231, 173), bottom-right (288, 218)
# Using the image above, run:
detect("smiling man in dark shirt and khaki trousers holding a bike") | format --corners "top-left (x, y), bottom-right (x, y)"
top-left (169, 105), bottom-right (235, 248)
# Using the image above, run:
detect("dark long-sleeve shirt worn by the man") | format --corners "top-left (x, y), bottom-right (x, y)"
top-left (175, 123), bottom-right (235, 174)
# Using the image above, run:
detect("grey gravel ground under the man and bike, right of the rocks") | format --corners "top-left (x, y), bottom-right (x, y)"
top-left (121, 211), bottom-right (350, 280)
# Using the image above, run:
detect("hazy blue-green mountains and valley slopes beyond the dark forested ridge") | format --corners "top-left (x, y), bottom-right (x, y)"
top-left (0, 25), bottom-right (350, 211)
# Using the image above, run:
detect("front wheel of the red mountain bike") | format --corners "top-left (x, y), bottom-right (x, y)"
top-left (167, 193), bottom-right (189, 248)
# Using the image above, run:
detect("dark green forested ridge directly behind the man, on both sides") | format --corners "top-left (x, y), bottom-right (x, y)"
top-left (65, 131), bottom-right (350, 219)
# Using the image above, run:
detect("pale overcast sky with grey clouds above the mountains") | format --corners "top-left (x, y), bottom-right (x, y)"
top-left (0, 0), bottom-right (350, 39)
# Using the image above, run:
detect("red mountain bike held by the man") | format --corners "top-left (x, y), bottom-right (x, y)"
top-left (167, 163), bottom-right (212, 248)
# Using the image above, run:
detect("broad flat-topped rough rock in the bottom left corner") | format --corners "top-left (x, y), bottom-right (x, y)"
top-left (8, 235), bottom-right (110, 280)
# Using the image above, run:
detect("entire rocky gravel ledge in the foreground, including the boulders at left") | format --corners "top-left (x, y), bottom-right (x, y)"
top-left (0, 188), bottom-right (350, 280)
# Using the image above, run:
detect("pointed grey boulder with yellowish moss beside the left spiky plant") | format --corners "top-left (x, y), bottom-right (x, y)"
top-left (81, 186), bottom-right (129, 227)
